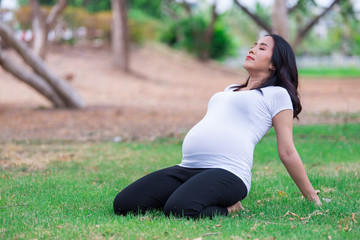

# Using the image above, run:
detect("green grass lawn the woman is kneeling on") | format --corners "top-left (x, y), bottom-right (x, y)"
top-left (0, 124), bottom-right (360, 239)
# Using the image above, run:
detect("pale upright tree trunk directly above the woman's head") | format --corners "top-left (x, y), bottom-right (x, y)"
top-left (272, 0), bottom-right (289, 41)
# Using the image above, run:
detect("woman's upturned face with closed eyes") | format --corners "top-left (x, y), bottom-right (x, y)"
top-left (243, 36), bottom-right (275, 74)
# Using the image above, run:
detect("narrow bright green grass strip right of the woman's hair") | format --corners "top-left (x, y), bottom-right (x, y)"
top-left (299, 68), bottom-right (360, 78)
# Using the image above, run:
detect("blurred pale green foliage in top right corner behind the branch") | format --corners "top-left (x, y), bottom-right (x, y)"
top-left (290, 0), bottom-right (360, 56)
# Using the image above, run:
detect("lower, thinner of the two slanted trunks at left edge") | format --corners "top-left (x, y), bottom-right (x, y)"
top-left (0, 50), bottom-right (65, 107)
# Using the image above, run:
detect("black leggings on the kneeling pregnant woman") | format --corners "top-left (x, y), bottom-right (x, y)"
top-left (114, 166), bottom-right (247, 218)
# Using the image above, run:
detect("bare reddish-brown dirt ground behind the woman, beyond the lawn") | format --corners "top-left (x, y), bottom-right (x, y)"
top-left (0, 45), bottom-right (360, 141)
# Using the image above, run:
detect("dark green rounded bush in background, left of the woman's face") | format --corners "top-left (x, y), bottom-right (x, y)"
top-left (161, 15), bottom-right (236, 59)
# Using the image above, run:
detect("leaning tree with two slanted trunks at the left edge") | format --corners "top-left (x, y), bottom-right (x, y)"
top-left (0, 21), bottom-right (85, 108)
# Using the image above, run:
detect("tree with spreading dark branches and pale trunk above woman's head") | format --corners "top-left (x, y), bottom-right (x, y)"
top-left (234, 0), bottom-right (340, 50)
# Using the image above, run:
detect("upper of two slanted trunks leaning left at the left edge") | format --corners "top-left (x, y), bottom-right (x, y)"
top-left (0, 21), bottom-right (85, 108)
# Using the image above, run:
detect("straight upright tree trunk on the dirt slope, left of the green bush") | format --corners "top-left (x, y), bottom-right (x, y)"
top-left (111, 0), bottom-right (129, 72)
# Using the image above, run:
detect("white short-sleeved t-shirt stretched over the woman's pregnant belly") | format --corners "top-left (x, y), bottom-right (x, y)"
top-left (179, 85), bottom-right (293, 193)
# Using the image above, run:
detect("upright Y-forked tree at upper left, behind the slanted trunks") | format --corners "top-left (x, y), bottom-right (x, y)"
top-left (29, 0), bottom-right (67, 59)
